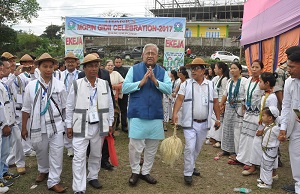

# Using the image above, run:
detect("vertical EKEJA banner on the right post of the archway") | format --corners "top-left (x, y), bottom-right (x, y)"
top-left (164, 38), bottom-right (185, 72)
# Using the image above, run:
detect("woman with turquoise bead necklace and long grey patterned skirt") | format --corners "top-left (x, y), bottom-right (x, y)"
top-left (218, 62), bottom-right (247, 160)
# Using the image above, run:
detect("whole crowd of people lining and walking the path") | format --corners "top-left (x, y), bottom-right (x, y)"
top-left (0, 44), bottom-right (300, 194)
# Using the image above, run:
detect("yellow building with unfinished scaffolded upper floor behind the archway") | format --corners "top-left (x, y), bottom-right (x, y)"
top-left (149, 0), bottom-right (244, 39)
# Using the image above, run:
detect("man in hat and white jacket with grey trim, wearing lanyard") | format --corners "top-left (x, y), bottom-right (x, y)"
top-left (66, 54), bottom-right (114, 194)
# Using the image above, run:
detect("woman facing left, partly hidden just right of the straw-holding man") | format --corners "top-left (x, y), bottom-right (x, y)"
top-left (209, 61), bottom-right (229, 148)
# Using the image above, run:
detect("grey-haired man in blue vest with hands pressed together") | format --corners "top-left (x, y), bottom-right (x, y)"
top-left (122, 44), bottom-right (172, 186)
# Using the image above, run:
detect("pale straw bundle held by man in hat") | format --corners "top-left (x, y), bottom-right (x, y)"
top-left (160, 124), bottom-right (183, 166)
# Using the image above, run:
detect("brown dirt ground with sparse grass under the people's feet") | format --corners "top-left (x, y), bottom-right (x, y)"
top-left (8, 123), bottom-right (293, 194)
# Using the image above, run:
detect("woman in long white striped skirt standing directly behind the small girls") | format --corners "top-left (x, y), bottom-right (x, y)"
top-left (236, 60), bottom-right (264, 170)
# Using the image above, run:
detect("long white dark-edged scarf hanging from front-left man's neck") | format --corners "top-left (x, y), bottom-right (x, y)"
top-left (30, 79), bottom-right (57, 143)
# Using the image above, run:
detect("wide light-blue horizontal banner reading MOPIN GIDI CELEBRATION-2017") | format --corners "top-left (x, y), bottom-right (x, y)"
top-left (65, 17), bottom-right (186, 38)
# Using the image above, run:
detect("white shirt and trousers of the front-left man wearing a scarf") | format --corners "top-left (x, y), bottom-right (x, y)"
top-left (22, 78), bottom-right (67, 188)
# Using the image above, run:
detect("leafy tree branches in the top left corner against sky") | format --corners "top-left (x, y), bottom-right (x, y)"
top-left (0, 0), bottom-right (41, 24)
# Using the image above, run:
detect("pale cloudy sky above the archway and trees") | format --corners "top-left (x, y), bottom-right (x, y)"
top-left (13, 0), bottom-right (153, 35)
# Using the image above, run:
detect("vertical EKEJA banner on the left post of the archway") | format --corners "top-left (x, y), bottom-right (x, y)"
top-left (65, 35), bottom-right (83, 62)
